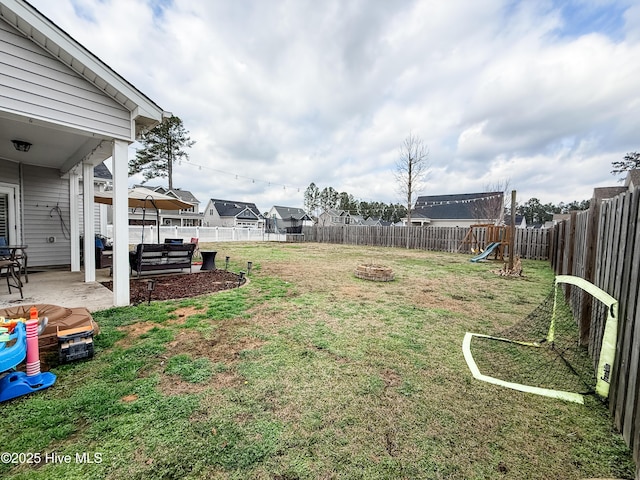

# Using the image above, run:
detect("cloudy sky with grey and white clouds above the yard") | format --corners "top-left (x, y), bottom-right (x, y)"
top-left (30, 0), bottom-right (640, 211)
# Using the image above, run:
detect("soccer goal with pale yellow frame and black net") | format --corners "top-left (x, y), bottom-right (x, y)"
top-left (462, 275), bottom-right (618, 403)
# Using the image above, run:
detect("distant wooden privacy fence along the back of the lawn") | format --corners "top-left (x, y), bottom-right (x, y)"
top-left (302, 225), bottom-right (551, 260)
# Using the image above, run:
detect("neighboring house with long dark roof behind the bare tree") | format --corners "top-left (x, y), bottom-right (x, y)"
top-left (403, 192), bottom-right (504, 227)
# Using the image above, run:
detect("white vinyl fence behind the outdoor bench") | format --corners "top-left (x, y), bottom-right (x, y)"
top-left (107, 225), bottom-right (286, 245)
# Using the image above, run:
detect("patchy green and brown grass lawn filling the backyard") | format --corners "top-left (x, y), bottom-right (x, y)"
top-left (0, 243), bottom-right (635, 480)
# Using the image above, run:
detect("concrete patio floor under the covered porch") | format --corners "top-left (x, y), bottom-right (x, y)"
top-left (0, 267), bottom-right (113, 312)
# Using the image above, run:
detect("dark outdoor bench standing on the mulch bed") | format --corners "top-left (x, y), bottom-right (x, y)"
top-left (129, 243), bottom-right (196, 276)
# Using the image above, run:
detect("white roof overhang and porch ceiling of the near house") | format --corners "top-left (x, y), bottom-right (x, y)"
top-left (0, 0), bottom-right (165, 174)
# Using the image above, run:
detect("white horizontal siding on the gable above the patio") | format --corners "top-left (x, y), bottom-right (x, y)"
top-left (0, 21), bottom-right (132, 139)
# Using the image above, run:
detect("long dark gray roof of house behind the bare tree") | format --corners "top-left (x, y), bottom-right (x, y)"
top-left (411, 192), bottom-right (504, 220)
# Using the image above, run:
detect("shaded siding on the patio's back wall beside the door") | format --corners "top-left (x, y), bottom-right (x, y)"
top-left (23, 165), bottom-right (71, 267)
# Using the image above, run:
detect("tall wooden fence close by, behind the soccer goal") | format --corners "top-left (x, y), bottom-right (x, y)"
top-left (551, 190), bottom-right (640, 472)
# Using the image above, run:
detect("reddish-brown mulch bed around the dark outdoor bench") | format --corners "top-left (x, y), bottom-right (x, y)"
top-left (102, 270), bottom-right (246, 305)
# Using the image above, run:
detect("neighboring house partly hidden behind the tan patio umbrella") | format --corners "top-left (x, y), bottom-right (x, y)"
top-left (129, 185), bottom-right (203, 227)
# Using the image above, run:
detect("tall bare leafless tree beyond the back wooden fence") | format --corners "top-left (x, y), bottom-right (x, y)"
top-left (395, 133), bottom-right (429, 226)
